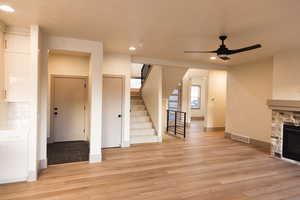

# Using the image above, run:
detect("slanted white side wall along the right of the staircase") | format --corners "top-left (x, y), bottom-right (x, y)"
top-left (142, 65), bottom-right (163, 137)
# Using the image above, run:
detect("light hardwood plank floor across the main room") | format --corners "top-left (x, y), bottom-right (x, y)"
top-left (0, 123), bottom-right (300, 200)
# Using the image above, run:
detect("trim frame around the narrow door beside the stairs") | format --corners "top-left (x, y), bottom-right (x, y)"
top-left (102, 74), bottom-right (125, 147)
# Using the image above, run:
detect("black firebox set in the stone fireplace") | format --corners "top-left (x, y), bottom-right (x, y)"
top-left (282, 124), bottom-right (300, 162)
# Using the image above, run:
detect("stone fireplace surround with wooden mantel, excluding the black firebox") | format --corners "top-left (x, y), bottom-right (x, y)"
top-left (268, 100), bottom-right (300, 163)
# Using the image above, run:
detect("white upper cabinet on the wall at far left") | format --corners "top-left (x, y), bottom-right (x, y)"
top-left (3, 34), bottom-right (32, 102)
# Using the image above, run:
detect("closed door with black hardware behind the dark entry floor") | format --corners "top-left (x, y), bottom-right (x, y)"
top-left (52, 77), bottom-right (87, 142)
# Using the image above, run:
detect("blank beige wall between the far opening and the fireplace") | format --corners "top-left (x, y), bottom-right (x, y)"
top-left (226, 59), bottom-right (273, 142)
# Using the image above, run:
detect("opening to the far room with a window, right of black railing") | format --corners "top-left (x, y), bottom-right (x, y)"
top-left (182, 68), bottom-right (227, 136)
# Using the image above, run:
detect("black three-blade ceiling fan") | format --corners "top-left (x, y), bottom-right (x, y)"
top-left (184, 35), bottom-right (261, 61)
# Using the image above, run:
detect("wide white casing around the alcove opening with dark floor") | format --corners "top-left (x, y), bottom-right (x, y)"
top-left (38, 37), bottom-right (103, 173)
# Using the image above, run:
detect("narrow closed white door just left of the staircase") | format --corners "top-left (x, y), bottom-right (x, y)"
top-left (102, 77), bottom-right (123, 148)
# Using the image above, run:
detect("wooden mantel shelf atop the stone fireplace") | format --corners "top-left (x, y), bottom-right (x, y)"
top-left (267, 99), bottom-right (300, 112)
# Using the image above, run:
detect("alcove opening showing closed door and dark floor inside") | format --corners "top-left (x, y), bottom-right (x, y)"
top-left (47, 51), bottom-right (90, 165)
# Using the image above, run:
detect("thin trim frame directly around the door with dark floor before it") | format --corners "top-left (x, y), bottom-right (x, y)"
top-left (49, 74), bottom-right (90, 143)
